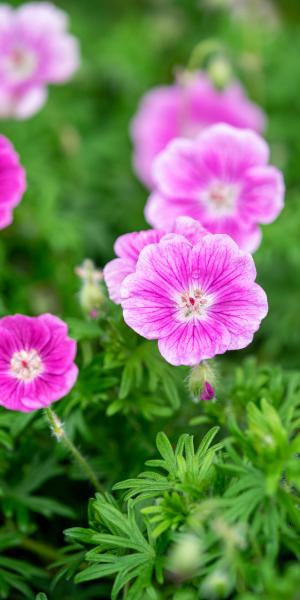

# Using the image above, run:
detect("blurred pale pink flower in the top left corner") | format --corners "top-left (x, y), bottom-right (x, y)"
top-left (0, 2), bottom-right (79, 119)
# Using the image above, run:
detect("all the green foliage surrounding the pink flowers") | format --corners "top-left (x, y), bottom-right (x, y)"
top-left (0, 0), bottom-right (300, 600)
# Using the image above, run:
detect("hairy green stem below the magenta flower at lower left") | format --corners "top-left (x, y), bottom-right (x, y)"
top-left (45, 406), bottom-right (103, 492)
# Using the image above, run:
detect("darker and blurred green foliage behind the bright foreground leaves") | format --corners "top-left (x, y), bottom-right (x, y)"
top-left (0, 0), bottom-right (300, 600)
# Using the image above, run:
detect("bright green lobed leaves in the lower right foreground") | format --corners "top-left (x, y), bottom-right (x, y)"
top-left (66, 377), bottom-right (300, 600)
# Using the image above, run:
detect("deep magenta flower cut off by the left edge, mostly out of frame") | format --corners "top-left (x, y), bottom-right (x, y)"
top-left (0, 135), bottom-right (26, 229)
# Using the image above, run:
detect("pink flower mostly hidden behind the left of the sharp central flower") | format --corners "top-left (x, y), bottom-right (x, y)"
top-left (103, 217), bottom-right (207, 304)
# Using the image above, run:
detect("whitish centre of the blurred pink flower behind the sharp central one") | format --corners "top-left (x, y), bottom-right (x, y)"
top-left (201, 182), bottom-right (238, 217)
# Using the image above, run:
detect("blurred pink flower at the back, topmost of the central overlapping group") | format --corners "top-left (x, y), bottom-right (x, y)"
top-left (131, 72), bottom-right (265, 188)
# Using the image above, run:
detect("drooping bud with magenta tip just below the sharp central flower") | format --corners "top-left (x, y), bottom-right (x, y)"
top-left (188, 361), bottom-right (216, 402)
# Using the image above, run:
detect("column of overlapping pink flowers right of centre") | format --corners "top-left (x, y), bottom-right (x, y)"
top-left (104, 73), bottom-right (284, 368)
